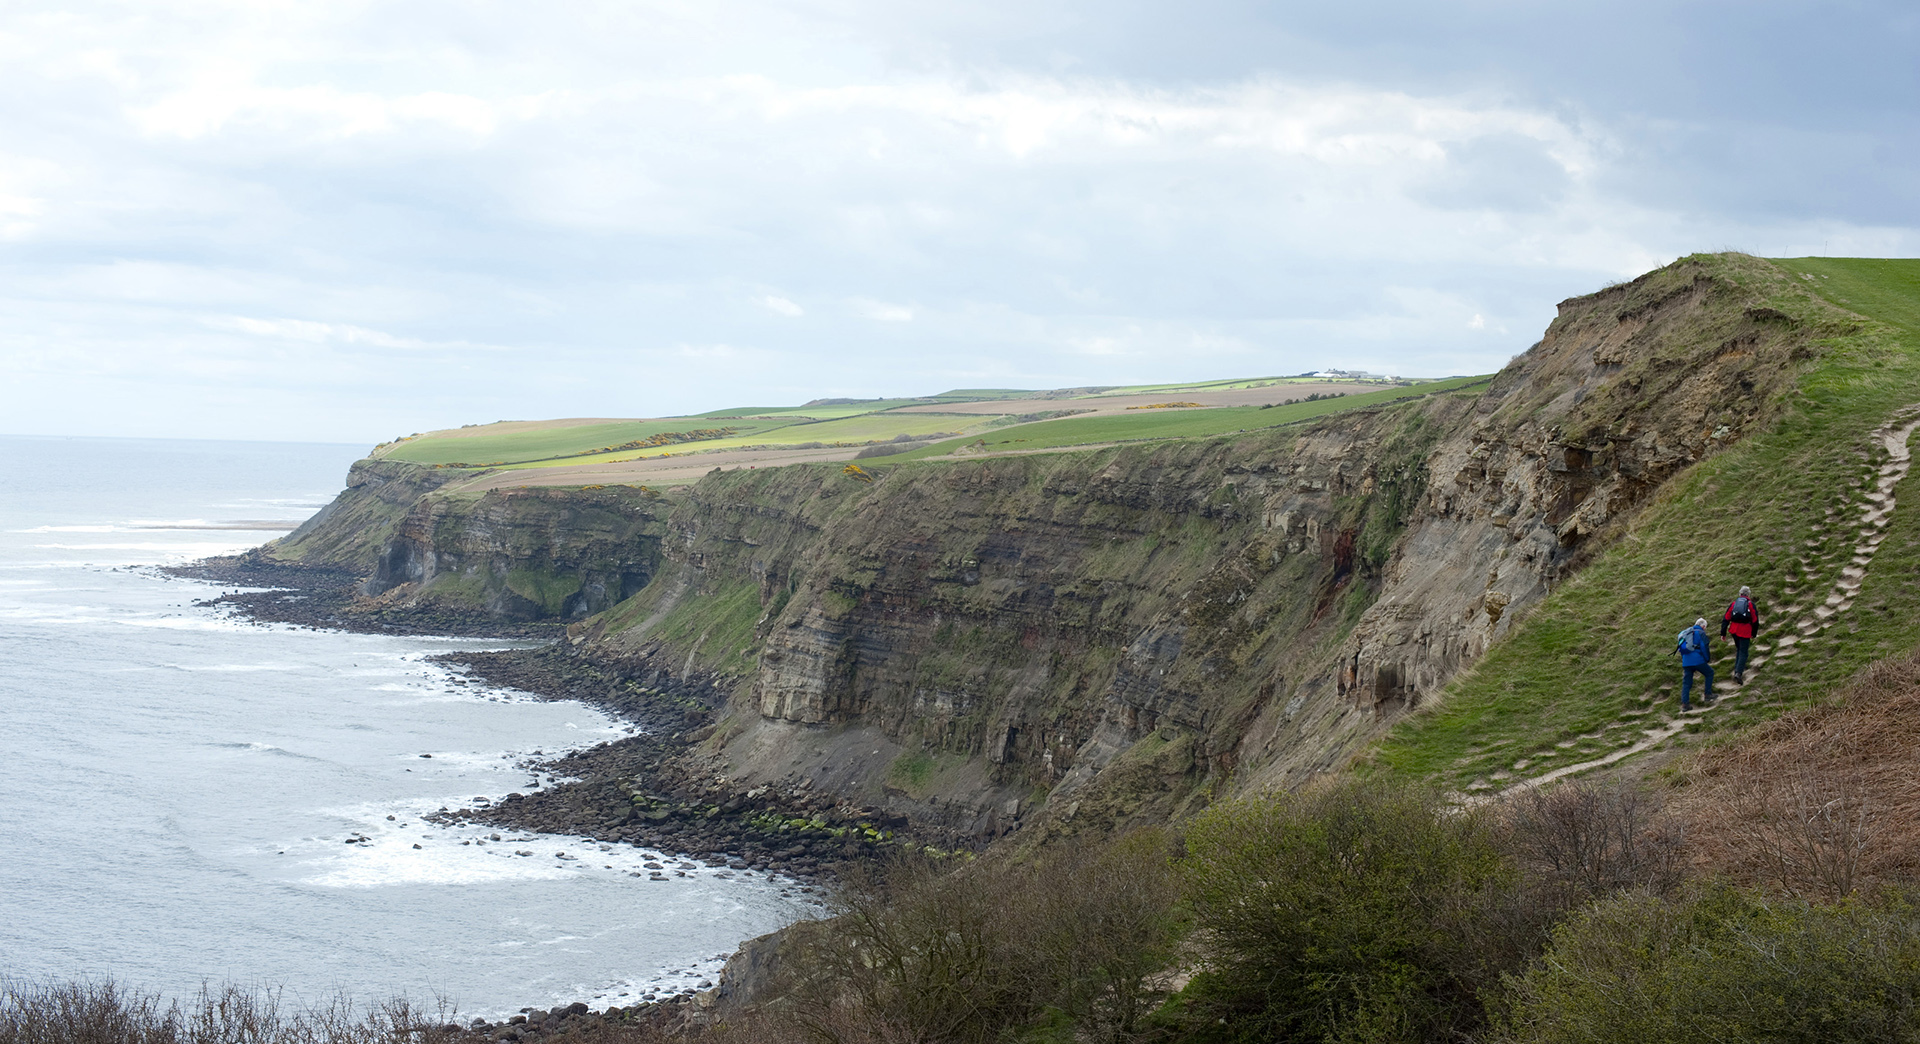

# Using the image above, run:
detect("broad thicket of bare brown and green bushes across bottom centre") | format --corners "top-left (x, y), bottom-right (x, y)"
top-left (744, 781), bottom-right (1678, 1044)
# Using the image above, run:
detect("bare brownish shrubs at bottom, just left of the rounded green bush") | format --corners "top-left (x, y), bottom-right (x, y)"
top-left (774, 831), bottom-right (1179, 1044)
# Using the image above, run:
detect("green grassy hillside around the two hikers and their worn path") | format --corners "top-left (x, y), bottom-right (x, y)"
top-left (1369, 255), bottom-right (1920, 789)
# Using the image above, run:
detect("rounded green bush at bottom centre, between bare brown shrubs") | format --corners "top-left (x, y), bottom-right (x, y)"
top-left (1183, 785), bottom-right (1513, 1042)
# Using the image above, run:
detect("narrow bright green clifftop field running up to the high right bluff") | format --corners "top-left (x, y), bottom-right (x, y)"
top-left (887, 376), bottom-right (1488, 463)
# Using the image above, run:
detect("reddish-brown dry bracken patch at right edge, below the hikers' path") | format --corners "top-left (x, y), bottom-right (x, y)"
top-left (1674, 651), bottom-right (1920, 898)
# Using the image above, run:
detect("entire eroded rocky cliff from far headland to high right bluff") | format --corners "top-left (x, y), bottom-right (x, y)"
top-left (259, 255), bottom-right (1851, 839)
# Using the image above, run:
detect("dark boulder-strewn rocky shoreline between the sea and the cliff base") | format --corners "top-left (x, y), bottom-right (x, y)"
top-left (165, 555), bottom-right (918, 1040)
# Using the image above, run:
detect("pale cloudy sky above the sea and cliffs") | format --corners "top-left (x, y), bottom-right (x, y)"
top-left (0, 0), bottom-right (1920, 443)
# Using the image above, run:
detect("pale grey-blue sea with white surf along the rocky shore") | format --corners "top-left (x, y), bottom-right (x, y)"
top-left (0, 436), bottom-right (816, 1017)
